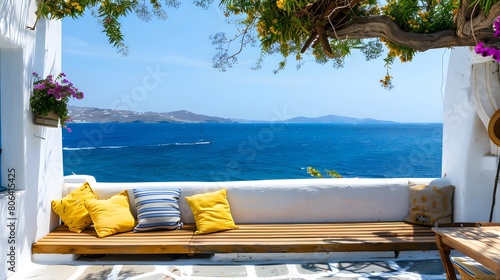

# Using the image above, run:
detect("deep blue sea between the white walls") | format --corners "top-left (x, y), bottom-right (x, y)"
top-left (63, 123), bottom-right (442, 182)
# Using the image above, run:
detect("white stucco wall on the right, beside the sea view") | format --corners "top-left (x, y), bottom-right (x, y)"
top-left (443, 48), bottom-right (500, 222)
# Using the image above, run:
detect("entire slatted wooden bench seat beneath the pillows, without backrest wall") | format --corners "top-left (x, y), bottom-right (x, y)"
top-left (33, 222), bottom-right (437, 254)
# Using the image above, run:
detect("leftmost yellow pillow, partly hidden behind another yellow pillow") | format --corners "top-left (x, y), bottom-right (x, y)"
top-left (51, 182), bottom-right (95, 233)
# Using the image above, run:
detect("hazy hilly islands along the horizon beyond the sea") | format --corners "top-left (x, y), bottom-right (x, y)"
top-left (68, 106), bottom-right (395, 124)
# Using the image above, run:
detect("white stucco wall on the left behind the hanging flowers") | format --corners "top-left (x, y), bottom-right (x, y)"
top-left (0, 0), bottom-right (63, 279)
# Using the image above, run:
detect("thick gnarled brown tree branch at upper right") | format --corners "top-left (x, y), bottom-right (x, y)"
top-left (327, 15), bottom-right (493, 51)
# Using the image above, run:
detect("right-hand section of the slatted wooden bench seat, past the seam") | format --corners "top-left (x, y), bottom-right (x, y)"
top-left (190, 222), bottom-right (437, 253)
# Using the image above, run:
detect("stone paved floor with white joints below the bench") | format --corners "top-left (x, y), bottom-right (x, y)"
top-left (9, 255), bottom-right (454, 280)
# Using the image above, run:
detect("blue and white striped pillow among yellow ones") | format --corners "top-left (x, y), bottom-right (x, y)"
top-left (133, 189), bottom-right (182, 232)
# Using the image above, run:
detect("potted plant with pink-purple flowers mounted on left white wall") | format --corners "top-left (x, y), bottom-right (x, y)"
top-left (30, 72), bottom-right (83, 131)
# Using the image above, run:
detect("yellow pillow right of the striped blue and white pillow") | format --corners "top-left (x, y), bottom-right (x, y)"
top-left (186, 189), bottom-right (238, 234)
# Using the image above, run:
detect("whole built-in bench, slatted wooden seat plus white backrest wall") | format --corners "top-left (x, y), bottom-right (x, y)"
top-left (32, 175), bottom-right (447, 256)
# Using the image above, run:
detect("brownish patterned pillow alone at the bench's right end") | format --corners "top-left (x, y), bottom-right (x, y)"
top-left (405, 184), bottom-right (455, 226)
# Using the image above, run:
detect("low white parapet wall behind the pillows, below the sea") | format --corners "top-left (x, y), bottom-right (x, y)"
top-left (63, 175), bottom-right (449, 223)
